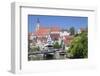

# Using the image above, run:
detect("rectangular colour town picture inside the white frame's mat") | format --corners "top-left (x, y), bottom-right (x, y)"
top-left (28, 15), bottom-right (88, 61)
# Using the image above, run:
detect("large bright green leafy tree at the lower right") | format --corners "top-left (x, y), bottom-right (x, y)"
top-left (68, 32), bottom-right (88, 58)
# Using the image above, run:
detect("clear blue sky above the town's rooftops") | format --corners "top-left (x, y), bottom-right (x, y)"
top-left (28, 15), bottom-right (88, 32)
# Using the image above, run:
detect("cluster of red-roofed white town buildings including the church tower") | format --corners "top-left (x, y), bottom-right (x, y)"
top-left (29, 19), bottom-right (73, 49)
